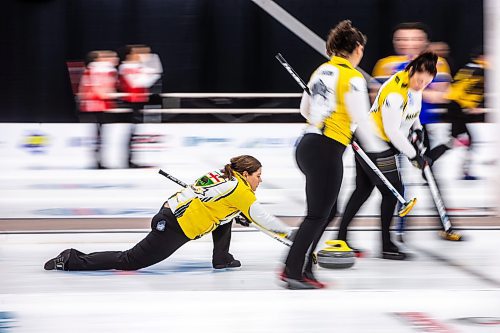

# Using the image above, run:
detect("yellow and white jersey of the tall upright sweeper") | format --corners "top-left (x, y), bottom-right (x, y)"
top-left (301, 56), bottom-right (368, 146)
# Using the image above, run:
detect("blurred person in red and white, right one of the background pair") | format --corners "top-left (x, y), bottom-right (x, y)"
top-left (118, 45), bottom-right (163, 168)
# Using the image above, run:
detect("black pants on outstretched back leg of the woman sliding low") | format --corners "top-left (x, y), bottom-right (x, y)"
top-left (65, 202), bottom-right (190, 271)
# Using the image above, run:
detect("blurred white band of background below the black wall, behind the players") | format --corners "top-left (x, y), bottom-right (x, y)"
top-left (0, 124), bottom-right (498, 218)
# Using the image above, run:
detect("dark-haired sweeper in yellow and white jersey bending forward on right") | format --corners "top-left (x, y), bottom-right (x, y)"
top-left (337, 52), bottom-right (438, 260)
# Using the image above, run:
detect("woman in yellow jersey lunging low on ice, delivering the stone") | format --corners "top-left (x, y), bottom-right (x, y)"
top-left (44, 155), bottom-right (292, 271)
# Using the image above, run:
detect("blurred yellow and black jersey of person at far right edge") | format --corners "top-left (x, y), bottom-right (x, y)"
top-left (446, 60), bottom-right (485, 109)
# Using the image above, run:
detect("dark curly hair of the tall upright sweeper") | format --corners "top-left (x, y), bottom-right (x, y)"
top-left (326, 20), bottom-right (366, 58)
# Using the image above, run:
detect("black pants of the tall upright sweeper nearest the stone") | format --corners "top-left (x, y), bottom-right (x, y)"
top-left (285, 134), bottom-right (345, 279)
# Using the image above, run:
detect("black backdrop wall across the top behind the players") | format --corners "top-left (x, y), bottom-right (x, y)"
top-left (0, 0), bottom-right (483, 122)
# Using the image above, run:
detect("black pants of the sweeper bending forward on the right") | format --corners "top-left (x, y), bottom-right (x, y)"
top-left (337, 150), bottom-right (403, 252)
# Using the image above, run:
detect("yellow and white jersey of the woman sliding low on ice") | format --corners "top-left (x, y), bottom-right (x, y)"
top-left (167, 170), bottom-right (291, 239)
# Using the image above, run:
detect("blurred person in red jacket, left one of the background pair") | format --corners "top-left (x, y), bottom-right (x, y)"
top-left (78, 50), bottom-right (118, 169)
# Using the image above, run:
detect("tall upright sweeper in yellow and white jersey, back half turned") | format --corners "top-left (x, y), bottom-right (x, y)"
top-left (280, 20), bottom-right (387, 289)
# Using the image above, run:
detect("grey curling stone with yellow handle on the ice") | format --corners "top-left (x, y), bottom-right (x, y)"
top-left (318, 240), bottom-right (356, 269)
